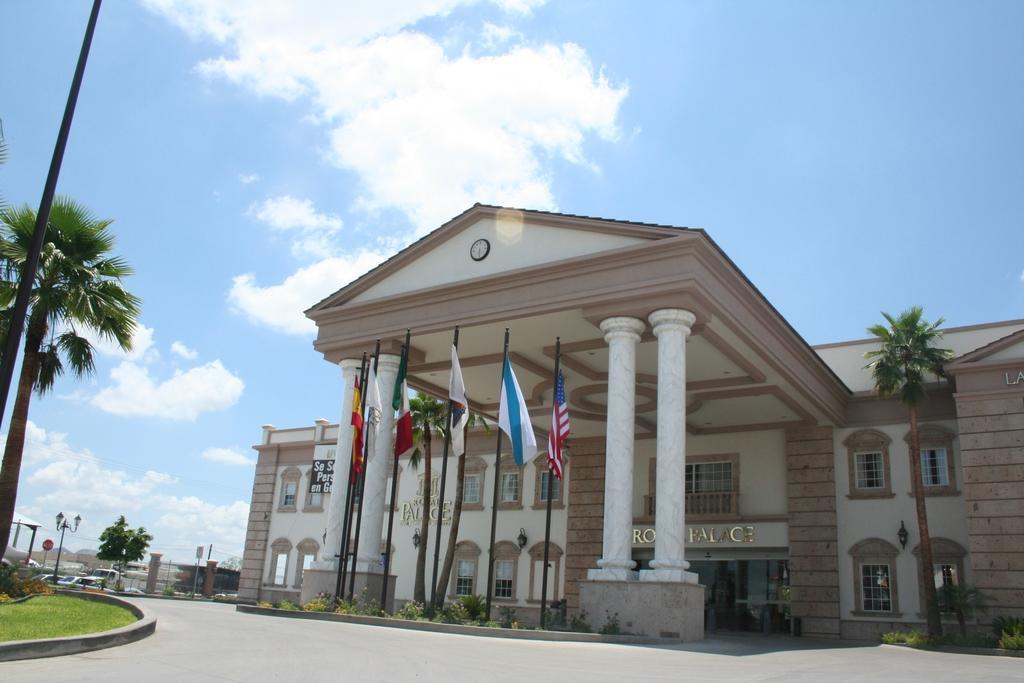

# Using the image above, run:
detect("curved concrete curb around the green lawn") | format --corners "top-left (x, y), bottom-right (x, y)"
top-left (0, 591), bottom-right (157, 661)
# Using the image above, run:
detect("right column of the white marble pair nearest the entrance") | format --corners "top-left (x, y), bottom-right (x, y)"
top-left (640, 308), bottom-right (697, 584)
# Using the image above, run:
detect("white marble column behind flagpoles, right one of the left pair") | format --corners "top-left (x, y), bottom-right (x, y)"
top-left (356, 353), bottom-right (400, 573)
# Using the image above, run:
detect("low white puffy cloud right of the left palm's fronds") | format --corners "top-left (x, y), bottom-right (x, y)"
top-left (91, 359), bottom-right (245, 420)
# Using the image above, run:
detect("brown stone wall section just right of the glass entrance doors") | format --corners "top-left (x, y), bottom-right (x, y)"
top-left (785, 427), bottom-right (840, 638)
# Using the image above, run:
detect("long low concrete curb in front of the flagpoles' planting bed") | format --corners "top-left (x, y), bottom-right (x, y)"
top-left (234, 605), bottom-right (682, 645)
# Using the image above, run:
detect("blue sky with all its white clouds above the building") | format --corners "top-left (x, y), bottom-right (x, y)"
top-left (0, 0), bottom-right (1024, 560)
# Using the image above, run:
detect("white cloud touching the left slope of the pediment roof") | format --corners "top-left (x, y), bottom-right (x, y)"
top-left (227, 251), bottom-right (386, 335)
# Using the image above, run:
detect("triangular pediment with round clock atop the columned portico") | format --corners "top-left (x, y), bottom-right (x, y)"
top-left (307, 205), bottom-right (686, 313)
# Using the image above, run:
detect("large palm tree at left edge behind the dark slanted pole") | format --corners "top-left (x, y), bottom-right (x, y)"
top-left (0, 197), bottom-right (140, 556)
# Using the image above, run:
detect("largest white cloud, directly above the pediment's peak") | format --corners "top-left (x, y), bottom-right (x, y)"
top-left (145, 0), bottom-right (627, 232)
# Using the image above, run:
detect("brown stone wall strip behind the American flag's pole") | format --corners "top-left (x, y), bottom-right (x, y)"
top-left (565, 443), bottom-right (604, 610)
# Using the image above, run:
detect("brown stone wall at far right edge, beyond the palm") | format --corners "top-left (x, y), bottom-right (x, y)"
top-left (956, 392), bottom-right (1024, 621)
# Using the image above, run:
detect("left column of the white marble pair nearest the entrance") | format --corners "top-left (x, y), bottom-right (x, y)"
top-left (587, 316), bottom-right (645, 581)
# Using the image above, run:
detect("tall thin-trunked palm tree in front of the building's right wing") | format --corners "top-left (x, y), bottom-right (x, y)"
top-left (864, 306), bottom-right (952, 638)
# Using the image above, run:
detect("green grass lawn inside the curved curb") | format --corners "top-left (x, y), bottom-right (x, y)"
top-left (0, 595), bottom-right (135, 641)
